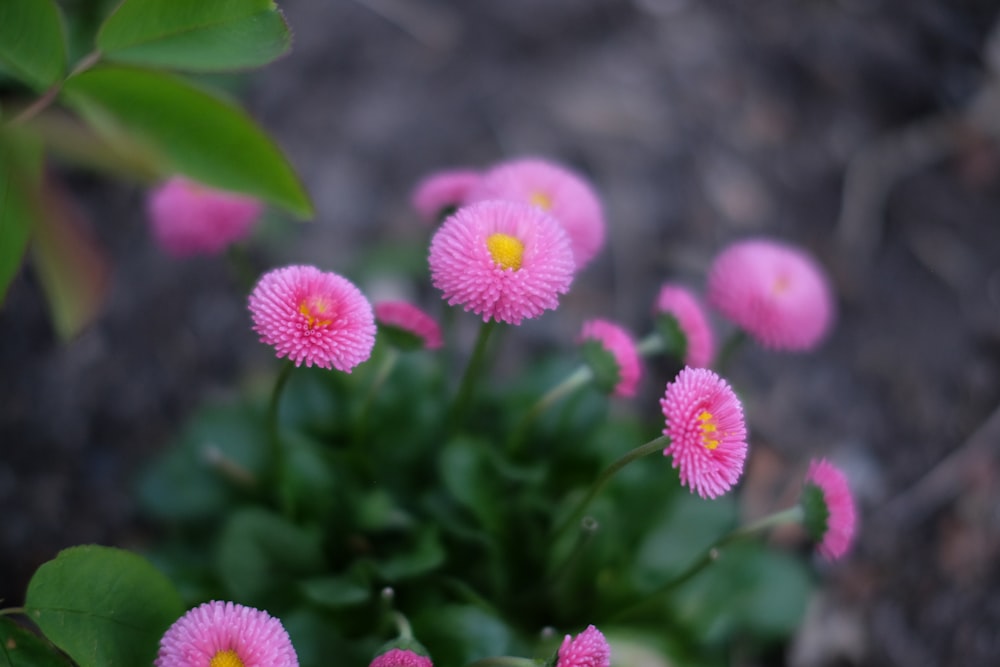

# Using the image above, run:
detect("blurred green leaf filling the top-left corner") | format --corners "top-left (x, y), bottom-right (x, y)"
top-left (0, 0), bottom-right (66, 90)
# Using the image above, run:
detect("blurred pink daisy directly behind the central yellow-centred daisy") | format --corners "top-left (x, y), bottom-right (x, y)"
top-left (467, 158), bottom-right (605, 269)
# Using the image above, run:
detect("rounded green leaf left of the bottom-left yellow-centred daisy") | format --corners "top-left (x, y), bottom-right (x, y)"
top-left (24, 546), bottom-right (184, 667)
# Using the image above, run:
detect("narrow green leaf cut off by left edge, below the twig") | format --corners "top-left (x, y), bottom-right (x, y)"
top-left (0, 127), bottom-right (42, 303)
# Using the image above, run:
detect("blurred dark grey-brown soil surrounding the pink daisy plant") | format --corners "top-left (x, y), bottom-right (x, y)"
top-left (0, 0), bottom-right (1000, 667)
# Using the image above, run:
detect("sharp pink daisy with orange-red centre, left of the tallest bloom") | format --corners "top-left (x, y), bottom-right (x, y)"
top-left (249, 266), bottom-right (375, 373)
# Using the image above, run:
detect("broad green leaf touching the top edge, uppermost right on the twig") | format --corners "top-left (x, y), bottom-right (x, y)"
top-left (97, 0), bottom-right (291, 71)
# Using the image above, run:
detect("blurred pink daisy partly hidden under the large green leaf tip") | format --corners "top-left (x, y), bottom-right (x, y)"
top-left (146, 176), bottom-right (263, 257)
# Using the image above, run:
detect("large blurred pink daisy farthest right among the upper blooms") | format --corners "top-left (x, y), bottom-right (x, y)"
top-left (708, 239), bottom-right (834, 350)
